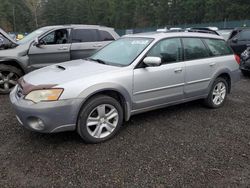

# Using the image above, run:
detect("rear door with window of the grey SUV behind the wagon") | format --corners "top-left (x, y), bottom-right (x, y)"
top-left (71, 28), bottom-right (104, 59)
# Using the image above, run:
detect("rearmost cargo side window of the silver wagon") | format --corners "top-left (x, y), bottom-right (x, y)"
top-left (205, 39), bottom-right (232, 56)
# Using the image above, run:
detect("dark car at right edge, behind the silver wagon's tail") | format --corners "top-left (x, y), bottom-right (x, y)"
top-left (227, 28), bottom-right (250, 56)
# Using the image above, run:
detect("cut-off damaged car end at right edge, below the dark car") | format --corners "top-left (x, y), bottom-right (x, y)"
top-left (240, 45), bottom-right (250, 76)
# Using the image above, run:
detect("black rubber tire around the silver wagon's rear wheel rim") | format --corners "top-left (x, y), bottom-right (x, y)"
top-left (206, 78), bottom-right (229, 108)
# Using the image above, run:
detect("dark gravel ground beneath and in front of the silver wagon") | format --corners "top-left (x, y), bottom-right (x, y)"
top-left (0, 78), bottom-right (250, 187)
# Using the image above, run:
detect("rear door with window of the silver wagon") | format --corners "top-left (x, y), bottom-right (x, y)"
top-left (182, 38), bottom-right (213, 98)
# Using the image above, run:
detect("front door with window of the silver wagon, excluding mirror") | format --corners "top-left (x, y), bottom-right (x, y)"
top-left (133, 38), bottom-right (185, 110)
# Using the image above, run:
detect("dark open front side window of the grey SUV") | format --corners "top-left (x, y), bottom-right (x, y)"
top-left (40, 29), bottom-right (69, 45)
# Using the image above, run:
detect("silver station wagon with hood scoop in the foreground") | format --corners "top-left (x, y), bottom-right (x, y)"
top-left (10, 32), bottom-right (240, 143)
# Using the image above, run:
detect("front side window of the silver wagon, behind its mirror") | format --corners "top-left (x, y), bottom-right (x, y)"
top-left (147, 38), bottom-right (182, 64)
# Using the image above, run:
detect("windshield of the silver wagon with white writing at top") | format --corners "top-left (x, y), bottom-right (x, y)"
top-left (90, 37), bottom-right (153, 66)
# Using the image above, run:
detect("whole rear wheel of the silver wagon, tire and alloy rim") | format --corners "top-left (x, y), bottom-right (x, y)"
top-left (205, 77), bottom-right (229, 109)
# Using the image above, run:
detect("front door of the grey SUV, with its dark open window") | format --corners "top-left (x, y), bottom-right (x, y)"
top-left (29, 29), bottom-right (71, 69)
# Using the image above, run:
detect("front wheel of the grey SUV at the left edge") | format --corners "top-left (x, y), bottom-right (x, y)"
top-left (0, 64), bottom-right (23, 94)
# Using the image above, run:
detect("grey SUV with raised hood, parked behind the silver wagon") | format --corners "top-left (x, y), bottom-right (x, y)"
top-left (0, 25), bottom-right (119, 94)
